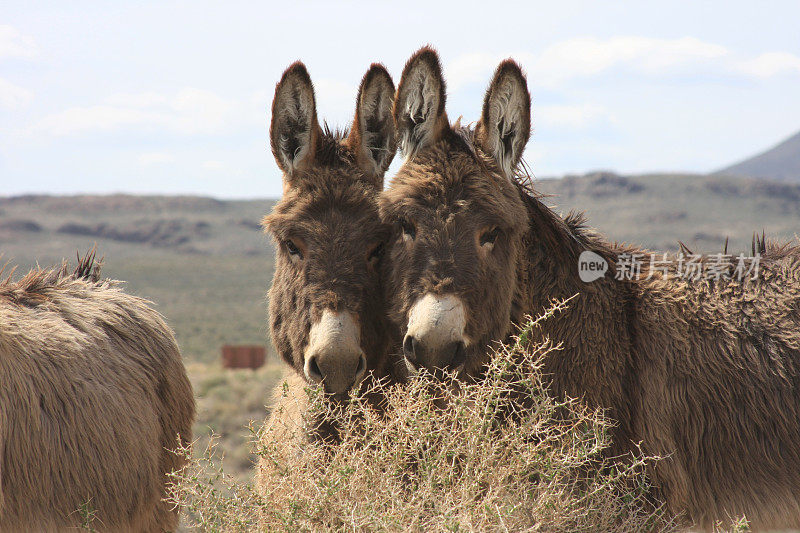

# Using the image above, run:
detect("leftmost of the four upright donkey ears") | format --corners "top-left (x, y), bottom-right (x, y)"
top-left (269, 61), bottom-right (320, 176)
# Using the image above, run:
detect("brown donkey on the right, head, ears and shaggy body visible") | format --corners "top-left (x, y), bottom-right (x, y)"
top-left (381, 48), bottom-right (800, 528)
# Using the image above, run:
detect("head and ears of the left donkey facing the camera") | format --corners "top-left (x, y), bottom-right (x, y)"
top-left (263, 62), bottom-right (396, 394)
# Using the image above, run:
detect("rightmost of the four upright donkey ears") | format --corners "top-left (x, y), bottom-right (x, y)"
top-left (475, 59), bottom-right (531, 179)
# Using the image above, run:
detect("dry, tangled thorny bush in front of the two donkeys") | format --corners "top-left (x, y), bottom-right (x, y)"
top-left (167, 303), bottom-right (752, 531)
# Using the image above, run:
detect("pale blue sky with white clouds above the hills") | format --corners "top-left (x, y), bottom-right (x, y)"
top-left (0, 0), bottom-right (800, 198)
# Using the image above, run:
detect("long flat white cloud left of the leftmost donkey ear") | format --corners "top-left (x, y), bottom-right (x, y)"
top-left (33, 88), bottom-right (242, 136)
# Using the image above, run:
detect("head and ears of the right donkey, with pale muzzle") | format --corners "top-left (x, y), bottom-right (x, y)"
top-left (381, 48), bottom-right (530, 374)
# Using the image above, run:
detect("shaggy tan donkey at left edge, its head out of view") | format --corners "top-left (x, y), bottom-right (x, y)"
top-left (0, 254), bottom-right (195, 532)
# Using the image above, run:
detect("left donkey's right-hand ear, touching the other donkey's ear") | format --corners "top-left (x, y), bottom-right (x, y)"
top-left (347, 63), bottom-right (397, 188)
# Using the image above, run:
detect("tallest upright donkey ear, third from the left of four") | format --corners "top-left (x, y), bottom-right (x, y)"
top-left (394, 46), bottom-right (450, 158)
